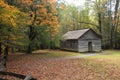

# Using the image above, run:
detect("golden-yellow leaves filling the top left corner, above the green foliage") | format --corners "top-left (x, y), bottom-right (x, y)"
top-left (0, 0), bottom-right (25, 27)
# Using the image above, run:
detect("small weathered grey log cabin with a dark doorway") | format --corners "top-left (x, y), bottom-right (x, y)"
top-left (60, 28), bottom-right (102, 52)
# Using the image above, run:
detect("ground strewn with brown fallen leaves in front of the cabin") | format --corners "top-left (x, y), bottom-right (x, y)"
top-left (1, 51), bottom-right (120, 80)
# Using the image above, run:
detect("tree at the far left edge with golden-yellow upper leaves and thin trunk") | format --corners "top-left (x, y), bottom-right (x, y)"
top-left (0, 0), bottom-right (25, 66)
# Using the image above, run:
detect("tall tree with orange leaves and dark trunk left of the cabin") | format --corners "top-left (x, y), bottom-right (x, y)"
top-left (15, 0), bottom-right (58, 53)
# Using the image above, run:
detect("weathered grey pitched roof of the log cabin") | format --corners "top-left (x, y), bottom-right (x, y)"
top-left (62, 28), bottom-right (100, 40)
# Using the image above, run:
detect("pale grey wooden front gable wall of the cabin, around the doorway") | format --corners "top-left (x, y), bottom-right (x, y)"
top-left (78, 30), bottom-right (101, 52)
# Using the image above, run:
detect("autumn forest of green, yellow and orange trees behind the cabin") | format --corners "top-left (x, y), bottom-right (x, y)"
top-left (0, 0), bottom-right (120, 55)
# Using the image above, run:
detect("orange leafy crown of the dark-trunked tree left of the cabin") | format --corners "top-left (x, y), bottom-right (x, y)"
top-left (19, 0), bottom-right (58, 32)
